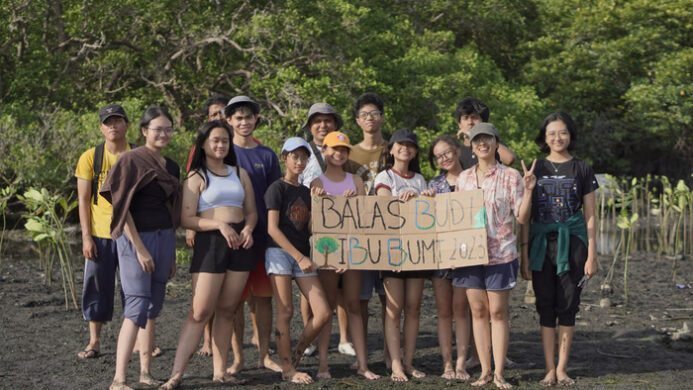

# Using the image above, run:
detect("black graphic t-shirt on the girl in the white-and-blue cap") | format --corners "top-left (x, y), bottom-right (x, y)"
top-left (265, 179), bottom-right (310, 256)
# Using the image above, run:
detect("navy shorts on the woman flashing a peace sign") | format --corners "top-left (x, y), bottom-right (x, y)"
top-left (452, 259), bottom-right (520, 291)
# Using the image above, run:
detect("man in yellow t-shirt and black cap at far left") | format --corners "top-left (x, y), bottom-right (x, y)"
top-left (75, 104), bottom-right (130, 359)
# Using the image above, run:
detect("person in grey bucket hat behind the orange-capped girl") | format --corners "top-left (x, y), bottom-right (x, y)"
top-left (301, 103), bottom-right (344, 187)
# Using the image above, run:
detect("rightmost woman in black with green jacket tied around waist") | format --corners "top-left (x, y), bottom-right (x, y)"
top-left (521, 112), bottom-right (598, 386)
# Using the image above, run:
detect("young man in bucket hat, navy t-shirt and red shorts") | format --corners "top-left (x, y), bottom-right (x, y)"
top-left (224, 95), bottom-right (281, 375)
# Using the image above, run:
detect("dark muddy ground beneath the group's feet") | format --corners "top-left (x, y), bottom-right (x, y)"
top-left (0, 232), bottom-right (693, 389)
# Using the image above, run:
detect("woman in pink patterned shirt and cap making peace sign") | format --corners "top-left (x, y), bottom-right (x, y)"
top-left (452, 123), bottom-right (536, 389)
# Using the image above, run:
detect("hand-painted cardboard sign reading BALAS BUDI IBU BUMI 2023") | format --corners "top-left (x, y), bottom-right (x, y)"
top-left (311, 190), bottom-right (488, 271)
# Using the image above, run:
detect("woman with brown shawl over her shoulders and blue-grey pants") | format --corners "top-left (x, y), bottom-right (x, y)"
top-left (99, 106), bottom-right (181, 390)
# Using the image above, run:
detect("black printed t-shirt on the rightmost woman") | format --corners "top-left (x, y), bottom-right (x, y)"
top-left (532, 158), bottom-right (599, 223)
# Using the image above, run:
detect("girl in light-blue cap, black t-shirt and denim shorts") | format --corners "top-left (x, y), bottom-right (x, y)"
top-left (265, 137), bottom-right (332, 384)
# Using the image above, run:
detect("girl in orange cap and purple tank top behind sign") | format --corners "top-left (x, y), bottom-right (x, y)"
top-left (310, 131), bottom-right (379, 380)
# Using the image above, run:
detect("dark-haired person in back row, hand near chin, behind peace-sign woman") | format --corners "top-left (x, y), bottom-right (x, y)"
top-left (453, 96), bottom-right (515, 169)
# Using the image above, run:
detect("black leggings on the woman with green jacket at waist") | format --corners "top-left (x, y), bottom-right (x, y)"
top-left (532, 234), bottom-right (587, 328)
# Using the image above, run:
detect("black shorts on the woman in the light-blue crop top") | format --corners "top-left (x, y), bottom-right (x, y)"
top-left (190, 222), bottom-right (258, 274)
